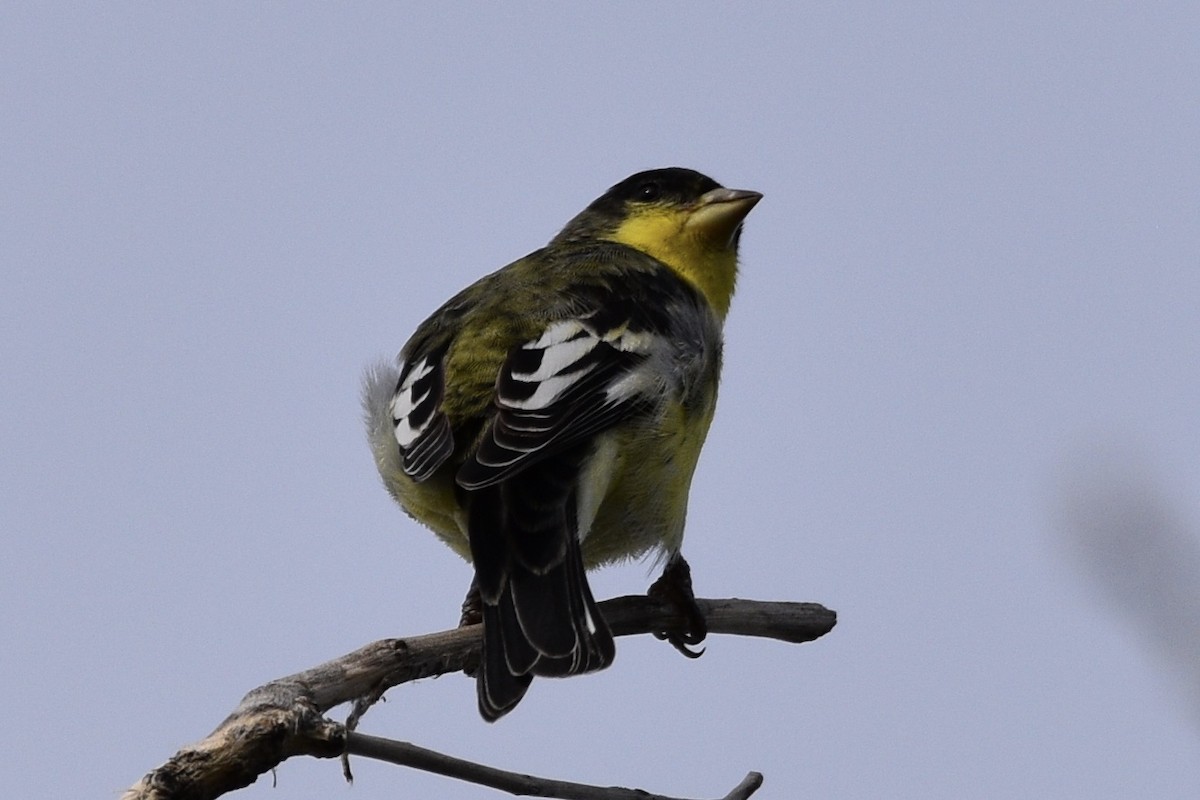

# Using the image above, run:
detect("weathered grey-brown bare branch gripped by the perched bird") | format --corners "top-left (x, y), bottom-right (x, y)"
top-left (122, 595), bottom-right (836, 800)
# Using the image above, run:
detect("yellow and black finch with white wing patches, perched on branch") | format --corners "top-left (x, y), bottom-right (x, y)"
top-left (362, 167), bottom-right (762, 722)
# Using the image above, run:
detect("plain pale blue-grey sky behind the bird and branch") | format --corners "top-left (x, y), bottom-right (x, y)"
top-left (0, 2), bottom-right (1200, 800)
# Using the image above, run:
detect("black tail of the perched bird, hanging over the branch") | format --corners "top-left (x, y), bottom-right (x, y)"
top-left (468, 457), bottom-right (616, 722)
